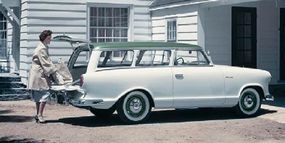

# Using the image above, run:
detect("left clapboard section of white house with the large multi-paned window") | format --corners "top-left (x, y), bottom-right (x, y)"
top-left (0, 0), bottom-right (152, 82)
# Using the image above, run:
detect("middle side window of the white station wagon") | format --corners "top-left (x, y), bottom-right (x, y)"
top-left (136, 50), bottom-right (171, 66)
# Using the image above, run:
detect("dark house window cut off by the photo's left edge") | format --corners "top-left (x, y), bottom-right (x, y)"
top-left (0, 12), bottom-right (7, 59)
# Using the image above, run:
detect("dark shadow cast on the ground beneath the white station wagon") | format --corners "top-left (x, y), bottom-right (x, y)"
top-left (47, 109), bottom-right (276, 127)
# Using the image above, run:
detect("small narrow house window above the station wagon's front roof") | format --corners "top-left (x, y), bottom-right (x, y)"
top-left (167, 20), bottom-right (177, 42)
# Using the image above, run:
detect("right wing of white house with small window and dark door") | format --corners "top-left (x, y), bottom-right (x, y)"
top-left (150, 0), bottom-right (285, 83)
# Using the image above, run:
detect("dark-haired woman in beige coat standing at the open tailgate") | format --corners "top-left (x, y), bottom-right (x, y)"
top-left (28, 30), bottom-right (56, 123)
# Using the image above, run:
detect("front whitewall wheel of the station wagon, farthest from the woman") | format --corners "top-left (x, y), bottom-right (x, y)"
top-left (236, 88), bottom-right (261, 117)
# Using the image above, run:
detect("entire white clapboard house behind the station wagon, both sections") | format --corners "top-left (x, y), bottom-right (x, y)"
top-left (0, 0), bottom-right (285, 83)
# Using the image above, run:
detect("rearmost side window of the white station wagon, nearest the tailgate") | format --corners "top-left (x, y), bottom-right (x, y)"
top-left (98, 50), bottom-right (134, 68)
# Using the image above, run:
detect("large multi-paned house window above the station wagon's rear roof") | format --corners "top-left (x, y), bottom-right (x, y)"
top-left (89, 7), bottom-right (129, 57)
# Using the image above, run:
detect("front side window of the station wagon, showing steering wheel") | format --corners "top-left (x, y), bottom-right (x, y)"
top-left (174, 50), bottom-right (209, 66)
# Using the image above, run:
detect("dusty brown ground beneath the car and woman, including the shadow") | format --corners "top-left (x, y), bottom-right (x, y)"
top-left (0, 98), bottom-right (285, 143)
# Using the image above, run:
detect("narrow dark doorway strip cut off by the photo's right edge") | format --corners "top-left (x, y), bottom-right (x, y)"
top-left (280, 8), bottom-right (285, 81)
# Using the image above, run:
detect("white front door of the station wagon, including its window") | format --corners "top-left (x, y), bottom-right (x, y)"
top-left (172, 50), bottom-right (225, 108)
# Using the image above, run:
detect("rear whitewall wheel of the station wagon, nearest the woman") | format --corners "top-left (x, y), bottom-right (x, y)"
top-left (117, 91), bottom-right (151, 123)
